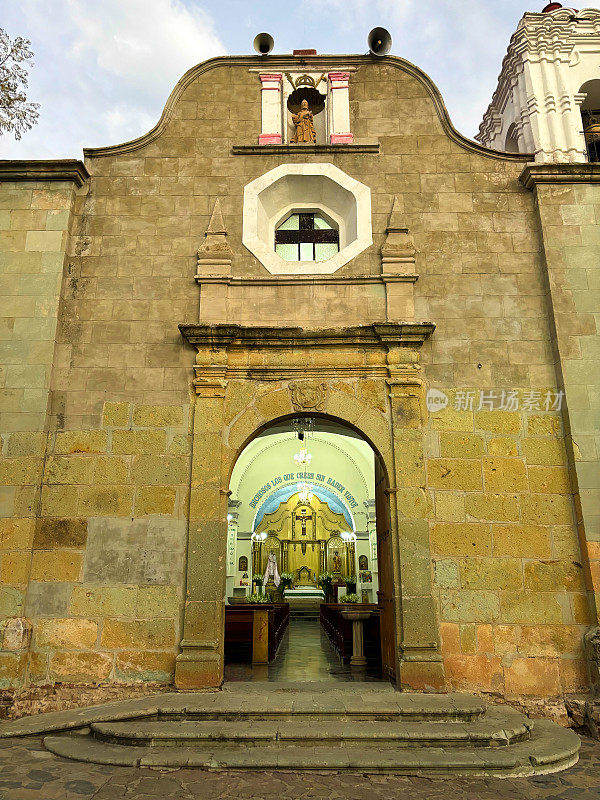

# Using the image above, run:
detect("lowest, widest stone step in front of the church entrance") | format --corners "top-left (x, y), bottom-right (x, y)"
top-left (39, 720), bottom-right (580, 777)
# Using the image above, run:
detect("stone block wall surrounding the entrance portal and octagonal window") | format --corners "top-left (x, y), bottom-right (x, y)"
top-left (0, 57), bottom-right (596, 694)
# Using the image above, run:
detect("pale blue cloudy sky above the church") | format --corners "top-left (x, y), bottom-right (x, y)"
top-left (0, 0), bottom-right (591, 158)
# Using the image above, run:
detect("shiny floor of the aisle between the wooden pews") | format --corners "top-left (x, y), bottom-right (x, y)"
top-left (225, 619), bottom-right (377, 681)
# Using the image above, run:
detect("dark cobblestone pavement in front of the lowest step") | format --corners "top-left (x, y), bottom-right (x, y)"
top-left (0, 738), bottom-right (600, 800)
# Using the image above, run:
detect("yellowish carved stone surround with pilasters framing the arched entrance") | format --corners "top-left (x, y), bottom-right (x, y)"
top-left (175, 323), bottom-right (444, 691)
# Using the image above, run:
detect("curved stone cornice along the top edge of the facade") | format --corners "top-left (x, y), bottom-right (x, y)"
top-left (83, 55), bottom-right (530, 162)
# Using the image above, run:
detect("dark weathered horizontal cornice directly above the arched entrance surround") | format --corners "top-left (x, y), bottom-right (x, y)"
top-left (179, 322), bottom-right (435, 350)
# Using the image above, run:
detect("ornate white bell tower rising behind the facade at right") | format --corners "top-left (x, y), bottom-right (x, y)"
top-left (475, 3), bottom-right (600, 162)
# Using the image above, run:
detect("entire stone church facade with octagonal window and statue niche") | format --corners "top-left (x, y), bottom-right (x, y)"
top-left (0, 10), bottom-right (600, 708)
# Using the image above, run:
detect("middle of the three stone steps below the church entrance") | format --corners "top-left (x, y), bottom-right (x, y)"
top-left (91, 709), bottom-right (532, 747)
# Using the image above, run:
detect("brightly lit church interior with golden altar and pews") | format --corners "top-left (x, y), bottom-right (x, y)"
top-left (225, 416), bottom-right (381, 680)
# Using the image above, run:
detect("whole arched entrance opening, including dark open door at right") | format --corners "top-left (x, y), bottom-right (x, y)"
top-left (225, 414), bottom-right (397, 680)
